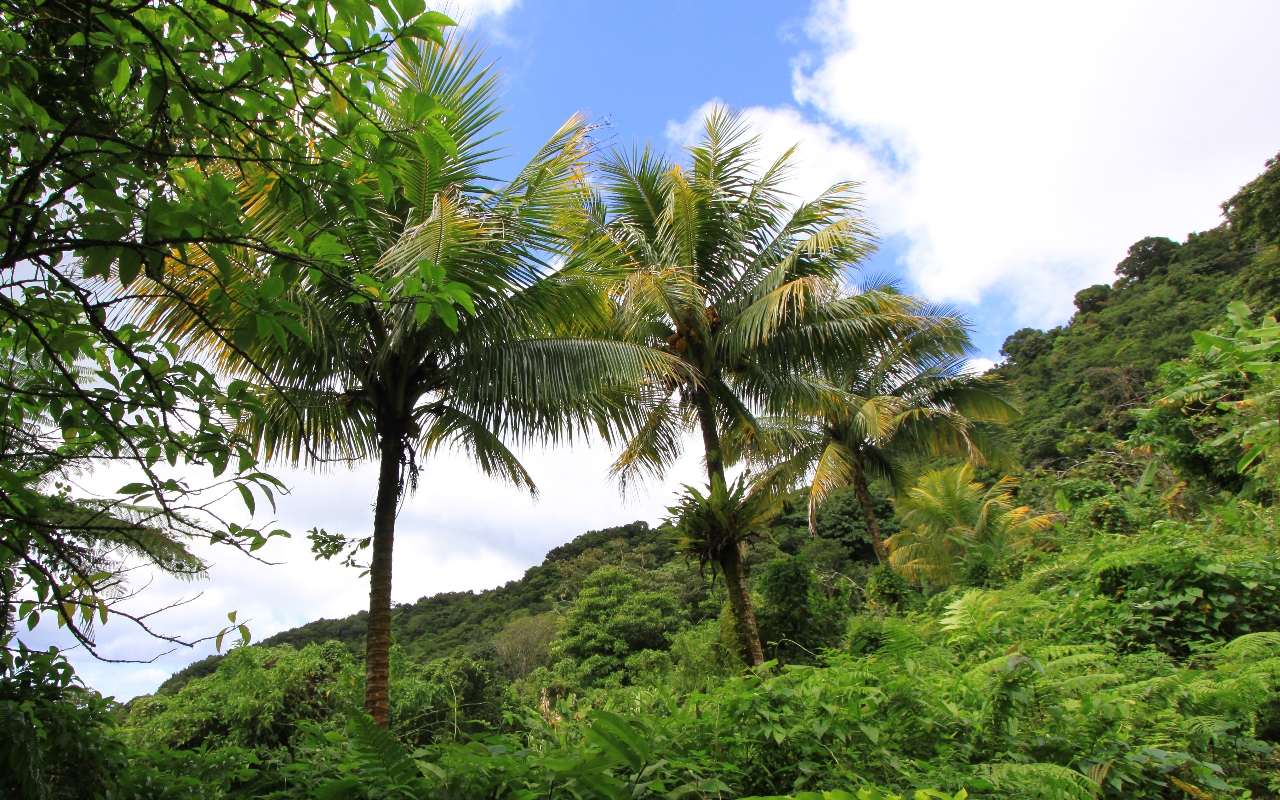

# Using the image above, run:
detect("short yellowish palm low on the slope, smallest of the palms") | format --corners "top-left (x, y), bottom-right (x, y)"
top-left (886, 463), bottom-right (1053, 586)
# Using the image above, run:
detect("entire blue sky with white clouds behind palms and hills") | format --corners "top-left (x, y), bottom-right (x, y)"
top-left (37, 0), bottom-right (1280, 698)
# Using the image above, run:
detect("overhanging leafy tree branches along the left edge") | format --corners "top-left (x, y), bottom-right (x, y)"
top-left (0, 0), bottom-right (452, 653)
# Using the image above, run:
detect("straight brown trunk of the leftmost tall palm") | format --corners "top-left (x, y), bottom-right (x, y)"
top-left (365, 435), bottom-right (404, 730)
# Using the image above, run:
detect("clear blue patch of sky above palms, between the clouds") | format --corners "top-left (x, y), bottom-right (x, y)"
top-left (480, 0), bottom-right (806, 143)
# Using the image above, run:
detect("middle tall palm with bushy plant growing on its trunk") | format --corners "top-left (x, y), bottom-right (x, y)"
top-left (602, 109), bottom-right (916, 666)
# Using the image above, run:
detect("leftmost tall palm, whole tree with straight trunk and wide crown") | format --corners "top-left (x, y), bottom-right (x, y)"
top-left (138, 40), bottom-right (685, 727)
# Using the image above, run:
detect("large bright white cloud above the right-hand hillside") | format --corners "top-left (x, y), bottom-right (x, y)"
top-left (669, 1), bottom-right (1280, 325)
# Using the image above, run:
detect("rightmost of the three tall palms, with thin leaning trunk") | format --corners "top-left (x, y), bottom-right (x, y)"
top-left (762, 318), bottom-right (1018, 563)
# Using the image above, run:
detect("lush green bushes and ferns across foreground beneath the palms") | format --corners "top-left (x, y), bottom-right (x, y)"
top-left (10, 496), bottom-right (1280, 800)
